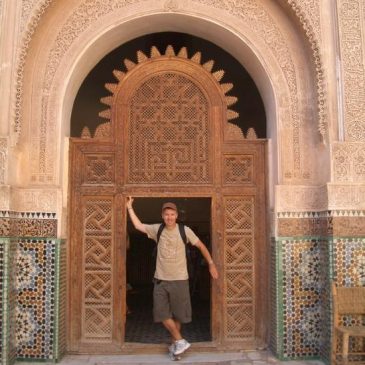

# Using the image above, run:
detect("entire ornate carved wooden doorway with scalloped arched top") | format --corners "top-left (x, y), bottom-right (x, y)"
top-left (68, 47), bottom-right (268, 353)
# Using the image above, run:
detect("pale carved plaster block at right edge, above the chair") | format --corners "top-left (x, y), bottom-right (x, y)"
top-left (328, 183), bottom-right (365, 210)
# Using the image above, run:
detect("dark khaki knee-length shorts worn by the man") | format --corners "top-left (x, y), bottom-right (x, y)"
top-left (153, 279), bottom-right (191, 323)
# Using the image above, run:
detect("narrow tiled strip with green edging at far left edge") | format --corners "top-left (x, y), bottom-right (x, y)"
top-left (0, 237), bottom-right (16, 364)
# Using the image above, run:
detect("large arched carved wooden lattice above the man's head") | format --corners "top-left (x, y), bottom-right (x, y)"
top-left (128, 72), bottom-right (212, 184)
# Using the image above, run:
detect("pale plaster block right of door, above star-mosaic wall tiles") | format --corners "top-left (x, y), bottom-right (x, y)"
top-left (275, 185), bottom-right (328, 212)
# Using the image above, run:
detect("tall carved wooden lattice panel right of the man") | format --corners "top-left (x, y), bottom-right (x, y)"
top-left (224, 197), bottom-right (255, 340)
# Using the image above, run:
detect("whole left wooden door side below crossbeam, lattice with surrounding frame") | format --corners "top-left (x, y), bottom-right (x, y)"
top-left (70, 188), bottom-right (123, 351)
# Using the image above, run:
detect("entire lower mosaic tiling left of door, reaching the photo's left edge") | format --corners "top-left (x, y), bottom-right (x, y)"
top-left (0, 238), bottom-right (66, 364)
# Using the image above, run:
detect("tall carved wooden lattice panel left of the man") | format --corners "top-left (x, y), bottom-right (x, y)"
top-left (82, 199), bottom-right (113, 342)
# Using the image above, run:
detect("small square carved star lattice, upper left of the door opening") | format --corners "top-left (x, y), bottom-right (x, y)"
top-left (84, 154), bottom-right (114, 184)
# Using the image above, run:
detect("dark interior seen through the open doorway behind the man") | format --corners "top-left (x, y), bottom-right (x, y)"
top-left (125, 198), bottom-right (211, 343)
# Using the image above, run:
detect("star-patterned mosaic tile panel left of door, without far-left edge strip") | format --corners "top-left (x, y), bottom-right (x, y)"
top-left (16, 238), bottom-right (66, 360)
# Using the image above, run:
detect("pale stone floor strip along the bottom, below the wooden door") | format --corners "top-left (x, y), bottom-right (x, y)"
top-left (16, 351), bottom-right (324, 365)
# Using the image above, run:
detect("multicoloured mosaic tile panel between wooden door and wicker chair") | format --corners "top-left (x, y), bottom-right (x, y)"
top-left (271, 237), bottom-right (329, 360)
